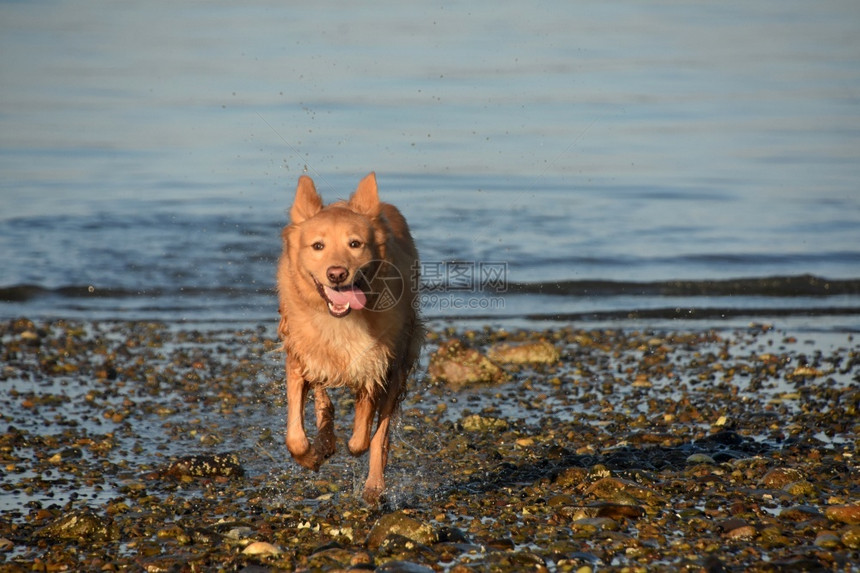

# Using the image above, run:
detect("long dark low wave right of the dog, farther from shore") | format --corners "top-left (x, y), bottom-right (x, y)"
top-left (507, 275), bottom-right (860, 297)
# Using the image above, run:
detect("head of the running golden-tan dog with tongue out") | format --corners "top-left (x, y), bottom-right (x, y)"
top-left (283, 173), bottom-right (385, 318)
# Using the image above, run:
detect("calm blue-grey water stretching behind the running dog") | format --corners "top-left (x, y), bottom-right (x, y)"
top-left (0, 0), bottom-right (860, 330)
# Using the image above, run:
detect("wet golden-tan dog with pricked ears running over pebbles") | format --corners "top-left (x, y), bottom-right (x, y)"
top-left (277, 173), bottom-right (424, 505)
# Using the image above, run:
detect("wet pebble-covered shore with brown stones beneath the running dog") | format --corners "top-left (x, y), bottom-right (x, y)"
top-left (0, 319), bottom-right (860, 573)
